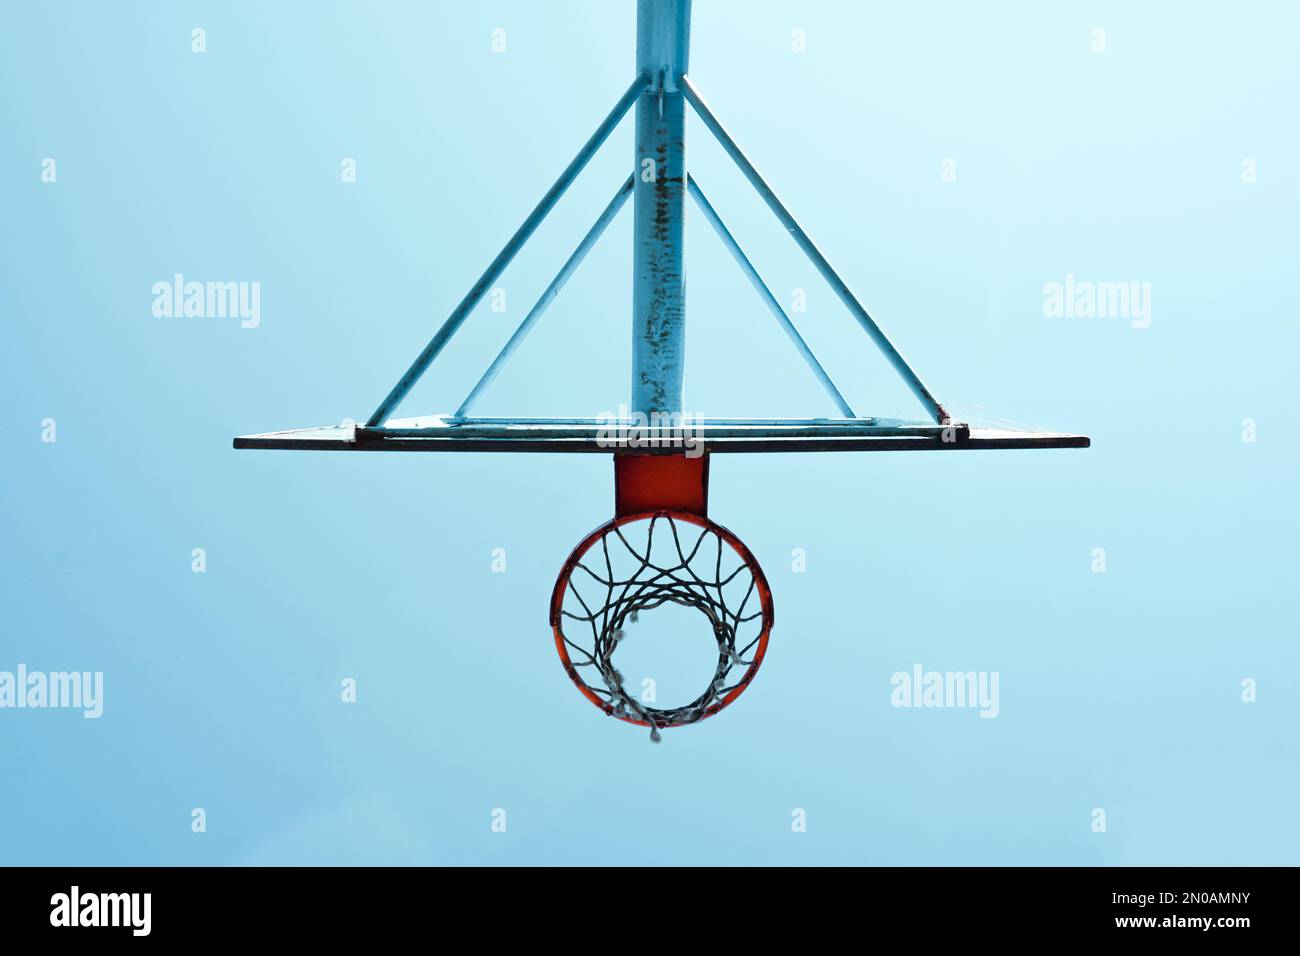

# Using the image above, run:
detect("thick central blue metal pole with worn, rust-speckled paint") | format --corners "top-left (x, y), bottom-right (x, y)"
top-left (632, 0), bottom-right (690, 415)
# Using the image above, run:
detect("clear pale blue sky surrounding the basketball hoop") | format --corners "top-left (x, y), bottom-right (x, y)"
top-left (0, 0), bottom-right (1300, 865)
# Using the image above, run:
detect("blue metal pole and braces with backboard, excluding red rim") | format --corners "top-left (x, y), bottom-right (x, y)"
top-left (234, 0), bottom-right (1088, 454)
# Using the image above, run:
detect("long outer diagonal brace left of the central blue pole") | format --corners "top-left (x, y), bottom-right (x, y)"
top-left (365, 74), bottom-right (647, 427)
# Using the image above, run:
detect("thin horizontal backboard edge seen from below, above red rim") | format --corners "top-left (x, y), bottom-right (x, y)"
top-left (234, 416), bottom-right (1089, 454)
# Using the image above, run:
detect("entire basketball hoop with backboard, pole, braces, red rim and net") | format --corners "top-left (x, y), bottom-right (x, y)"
top-left (234, 0), bottom-right (1089, 740)
